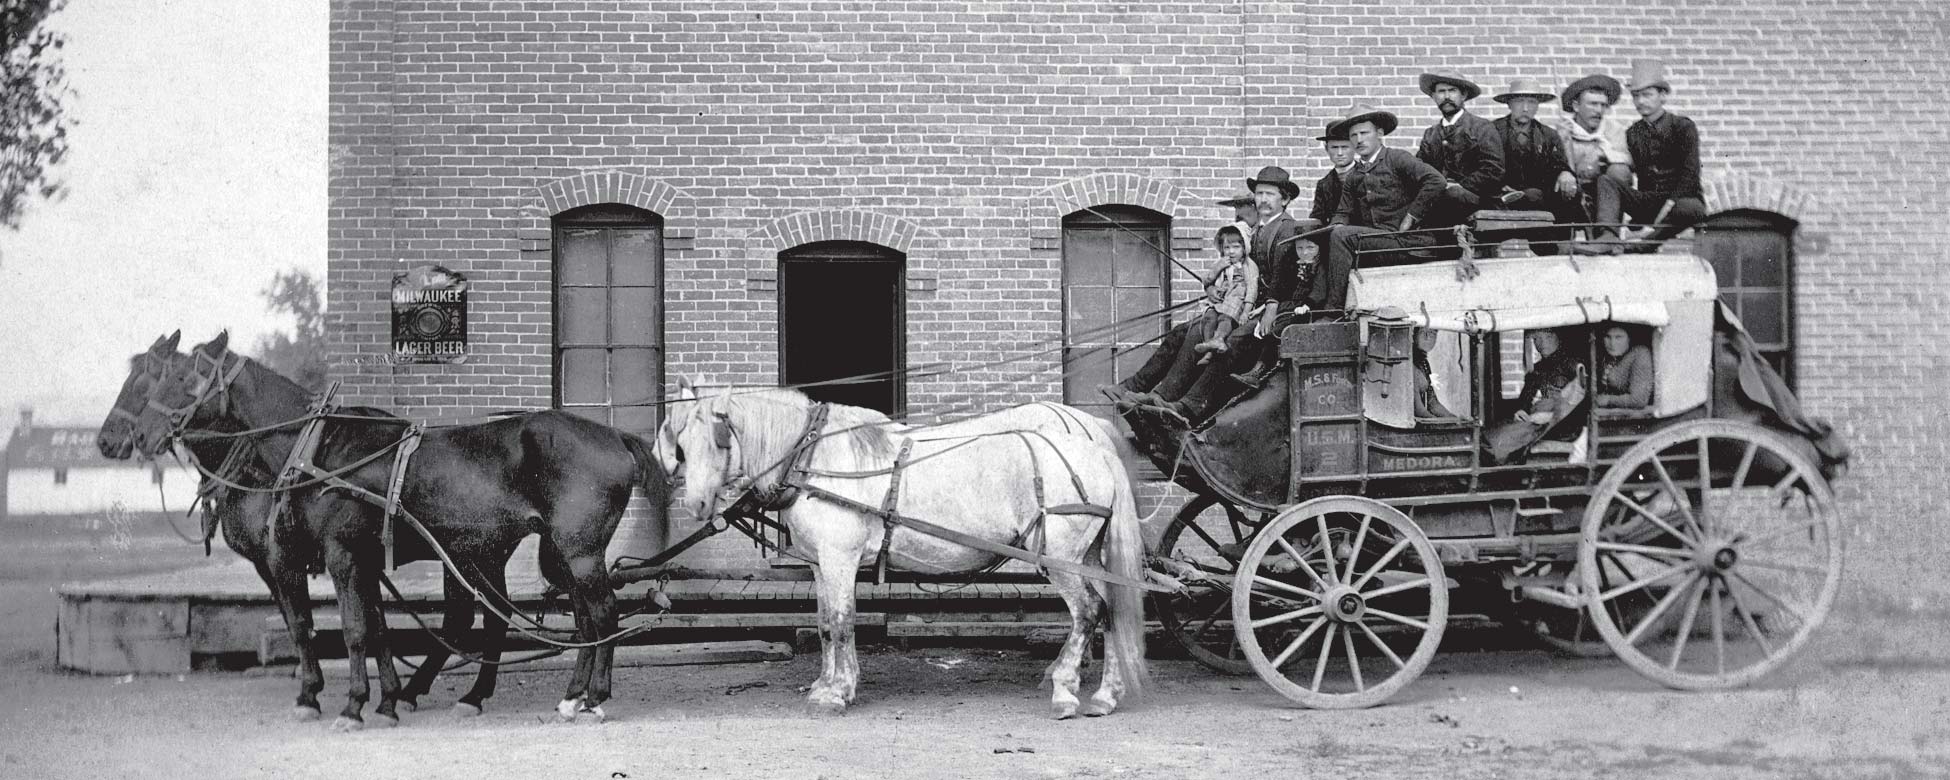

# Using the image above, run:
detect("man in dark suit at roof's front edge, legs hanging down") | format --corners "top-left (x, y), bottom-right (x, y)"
top-left (1307, 105), bottom-right (1445, 312)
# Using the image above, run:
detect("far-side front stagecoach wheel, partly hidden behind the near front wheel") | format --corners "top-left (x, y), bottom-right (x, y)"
top-left (1152, 495), bottom-right (1256, 675)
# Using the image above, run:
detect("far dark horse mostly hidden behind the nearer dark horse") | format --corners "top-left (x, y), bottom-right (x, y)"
top-left (96, 332), bottom-right (549, 720)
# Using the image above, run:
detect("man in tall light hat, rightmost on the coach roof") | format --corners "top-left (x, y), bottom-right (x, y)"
top-left (1597, 60), bottom-right (1706, 252)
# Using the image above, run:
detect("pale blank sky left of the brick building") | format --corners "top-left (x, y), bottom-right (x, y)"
top-left (0, 0), bottom-right (328, 443)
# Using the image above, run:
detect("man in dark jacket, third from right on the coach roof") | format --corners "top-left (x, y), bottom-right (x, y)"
top-left (1492, 78), bottom-right (1591, 255)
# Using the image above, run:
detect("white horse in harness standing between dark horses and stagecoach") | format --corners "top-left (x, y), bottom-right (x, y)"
top-left (659, 386), bottom-right (1147, 718)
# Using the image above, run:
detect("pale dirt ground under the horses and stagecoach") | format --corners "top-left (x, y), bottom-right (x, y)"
top-left (0, 526), bottom-right (1950, 780)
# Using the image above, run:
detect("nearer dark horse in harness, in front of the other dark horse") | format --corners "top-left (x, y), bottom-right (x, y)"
top-left (123, 333), bottom-right (669, 727)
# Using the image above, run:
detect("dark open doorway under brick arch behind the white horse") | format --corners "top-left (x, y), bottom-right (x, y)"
top-left (778, 242), bottom-right (907, 415)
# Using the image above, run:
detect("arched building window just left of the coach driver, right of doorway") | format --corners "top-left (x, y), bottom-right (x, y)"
top-left (1063, 205), bottom-right (1172, 417)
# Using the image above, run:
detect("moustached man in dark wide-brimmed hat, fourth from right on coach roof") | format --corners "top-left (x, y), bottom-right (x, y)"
top-left (1416, 68), bottom-right (1503, 228)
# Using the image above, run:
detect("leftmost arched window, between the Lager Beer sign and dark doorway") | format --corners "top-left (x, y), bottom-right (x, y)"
top-left (554, 203), bottom-right (663, 433)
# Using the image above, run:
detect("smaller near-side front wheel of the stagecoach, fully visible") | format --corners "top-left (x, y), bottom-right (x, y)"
top-left (1232, 495), bottom-right (1449, 710)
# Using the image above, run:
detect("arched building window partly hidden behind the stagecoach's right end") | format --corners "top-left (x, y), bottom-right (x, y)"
top-left (1695, 209), bottom-right (1796, 386)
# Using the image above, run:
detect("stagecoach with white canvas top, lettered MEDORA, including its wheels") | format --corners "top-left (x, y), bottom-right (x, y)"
top-left (1125, 240), bottom-right (1841, 708)
